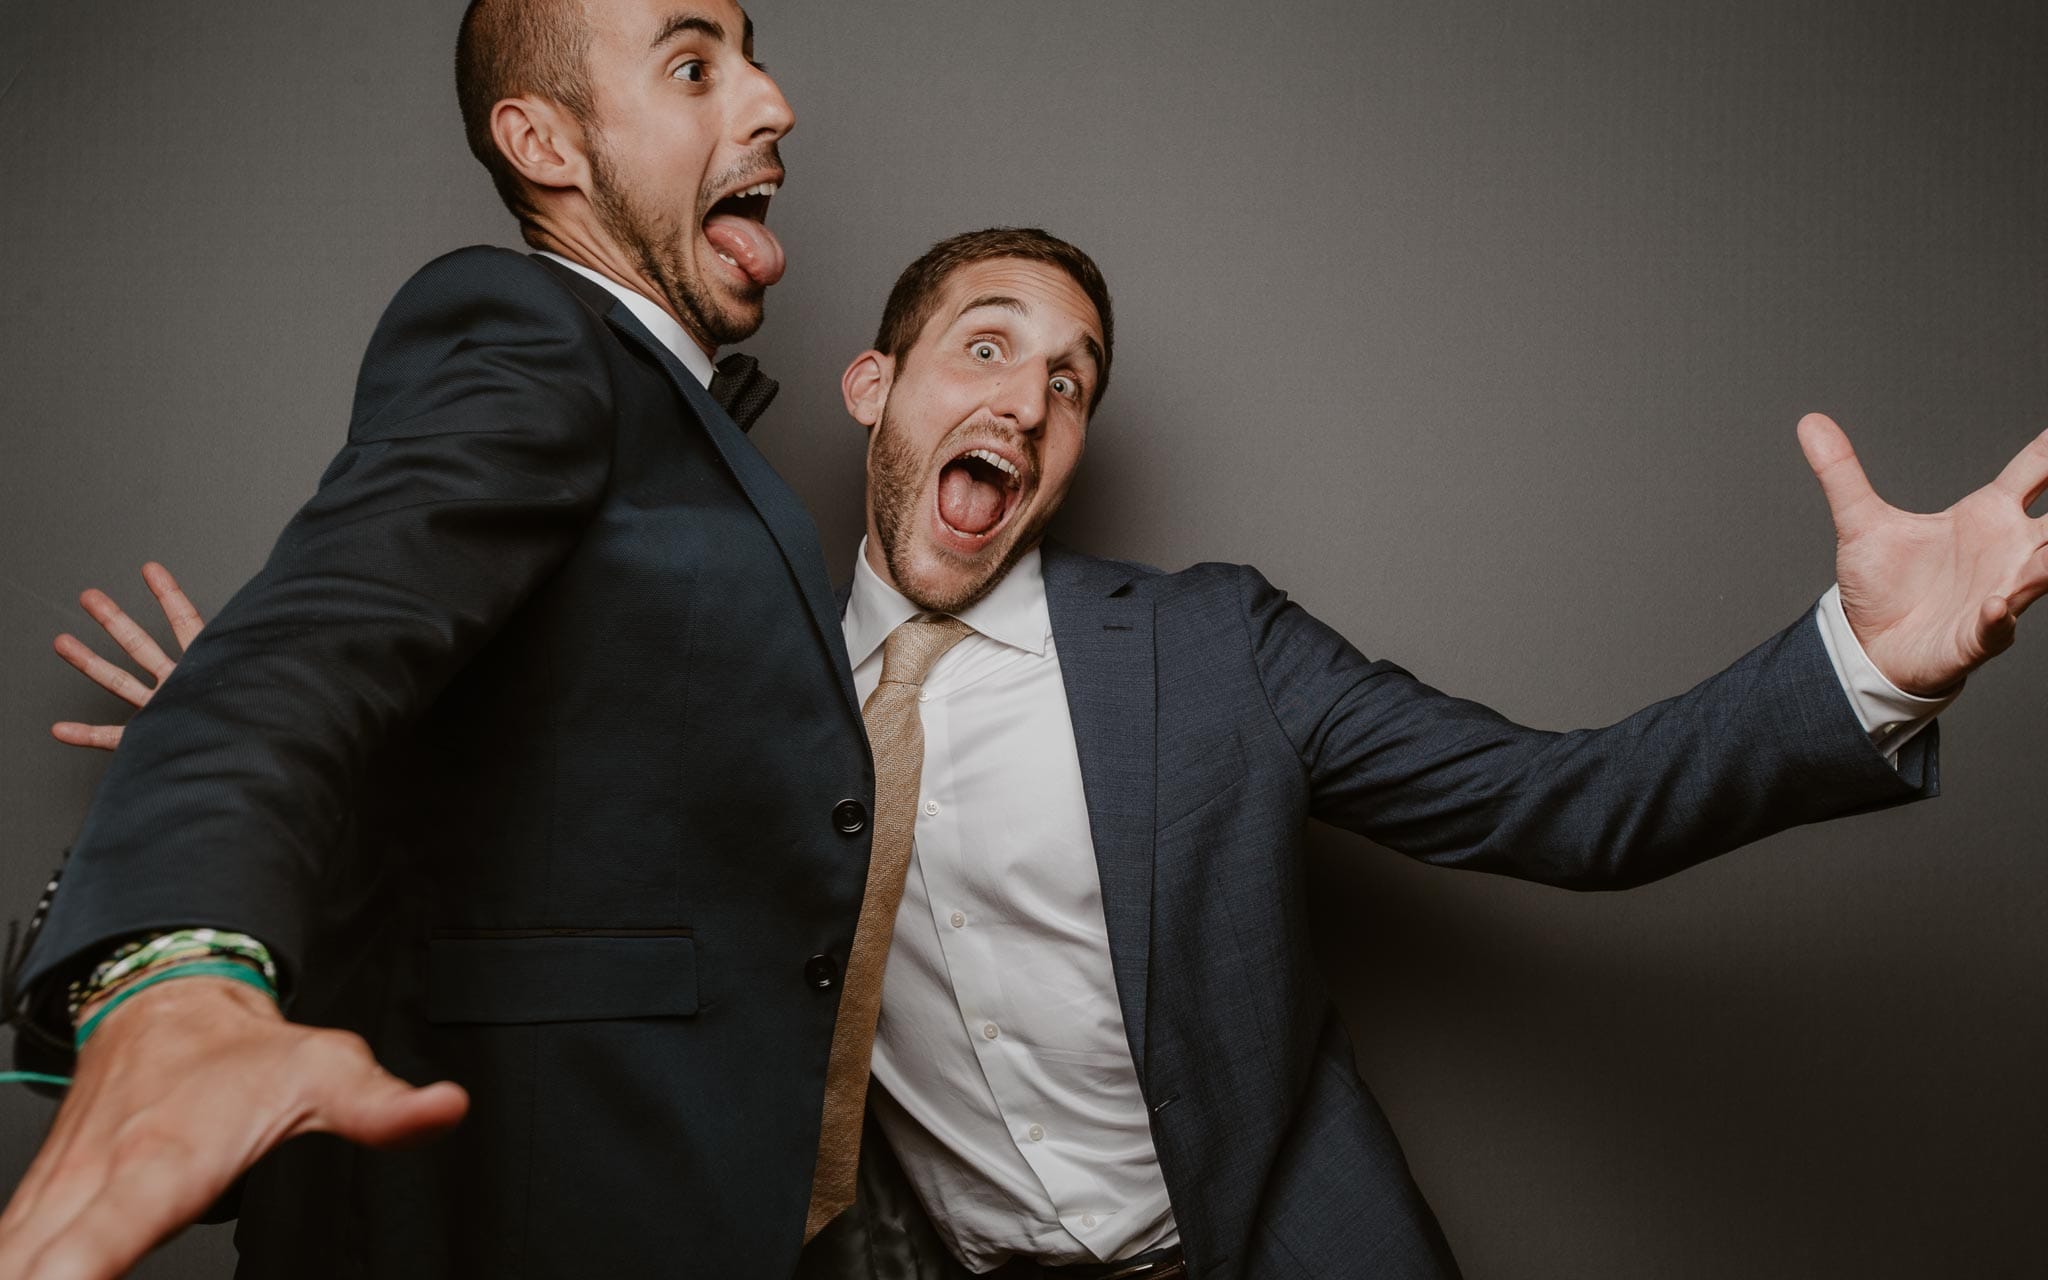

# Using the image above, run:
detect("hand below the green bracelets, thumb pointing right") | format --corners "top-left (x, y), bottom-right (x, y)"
top-left (0, 977), bottom-right (469, 1280)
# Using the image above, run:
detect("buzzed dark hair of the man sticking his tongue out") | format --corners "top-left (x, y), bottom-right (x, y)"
top-left (455, 0), bottom-right (596, 221)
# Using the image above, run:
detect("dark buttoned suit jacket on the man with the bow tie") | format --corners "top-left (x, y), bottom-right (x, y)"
top-left (20, 248), bottom-right (872, 1280)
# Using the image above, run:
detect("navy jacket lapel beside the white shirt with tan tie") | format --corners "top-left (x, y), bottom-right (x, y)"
top-left (1044, 543), bottom-right (1159, 1079)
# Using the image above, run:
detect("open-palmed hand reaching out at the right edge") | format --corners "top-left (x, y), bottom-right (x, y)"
top-left (1798, 414), bottom-right (2048, 696)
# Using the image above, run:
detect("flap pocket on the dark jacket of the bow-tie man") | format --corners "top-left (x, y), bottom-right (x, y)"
top-left (426, 932), bottom-right (696, 1024)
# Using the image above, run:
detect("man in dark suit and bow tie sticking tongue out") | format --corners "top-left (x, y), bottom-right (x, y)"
top-left (0, 0), bottom-right (872, 1280)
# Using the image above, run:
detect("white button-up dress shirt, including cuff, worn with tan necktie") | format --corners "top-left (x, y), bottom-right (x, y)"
top-left (844, 543), bottom-right (1952, 1272)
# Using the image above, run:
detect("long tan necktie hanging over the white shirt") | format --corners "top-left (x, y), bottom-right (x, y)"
top-left (803, 612), bottom-right (973, 1241)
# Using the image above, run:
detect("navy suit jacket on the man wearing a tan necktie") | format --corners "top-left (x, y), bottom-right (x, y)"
top-left (801, 545), bottom-right (1937, 1280)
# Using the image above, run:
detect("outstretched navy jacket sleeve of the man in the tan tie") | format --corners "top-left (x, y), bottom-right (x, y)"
top-left (1239, 569), bottom-right (1937, 889)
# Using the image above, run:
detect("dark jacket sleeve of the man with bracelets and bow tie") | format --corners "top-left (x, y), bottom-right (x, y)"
top-left (23, 250), bottom-right (612, 995)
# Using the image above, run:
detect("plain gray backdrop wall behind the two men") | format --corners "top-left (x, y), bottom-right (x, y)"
top-left (0, 0), bottom-right (2048, 1280)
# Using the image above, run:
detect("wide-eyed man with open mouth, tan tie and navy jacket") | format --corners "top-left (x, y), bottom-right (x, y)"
top-left (19, 219), bottom-right (2048, 1280)
